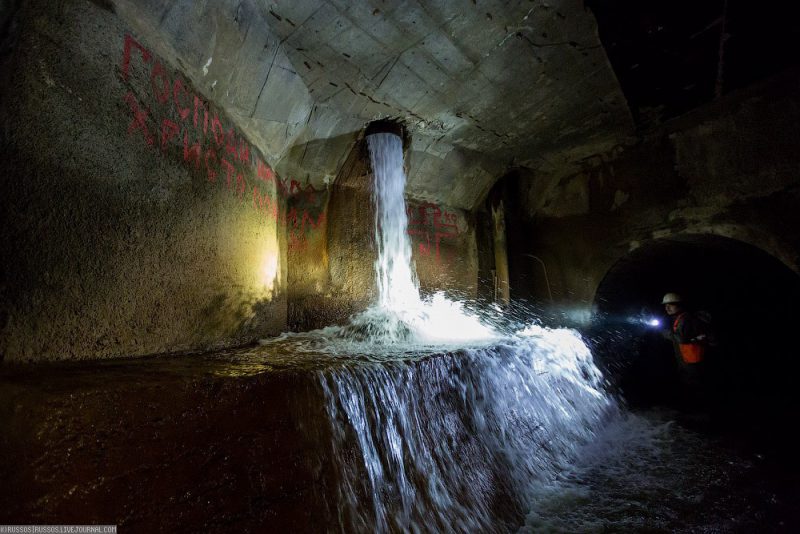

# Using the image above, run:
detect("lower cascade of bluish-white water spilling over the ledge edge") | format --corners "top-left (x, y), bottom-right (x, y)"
top-left (320, 327), bottom-right (617, 532)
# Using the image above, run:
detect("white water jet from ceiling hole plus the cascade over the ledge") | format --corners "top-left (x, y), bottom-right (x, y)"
top-left (260, 130), bottom-right (620, 532)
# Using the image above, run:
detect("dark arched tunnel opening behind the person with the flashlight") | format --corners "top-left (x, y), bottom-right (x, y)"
top-left (593, 235), bottom-right (800, 436)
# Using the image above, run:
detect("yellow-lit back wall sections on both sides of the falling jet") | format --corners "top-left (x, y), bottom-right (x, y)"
top-left (288, 139), bottom-right (478, 330)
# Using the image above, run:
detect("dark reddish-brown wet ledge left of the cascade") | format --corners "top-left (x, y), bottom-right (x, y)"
top-left (0, 349), bottom-right (330, 532)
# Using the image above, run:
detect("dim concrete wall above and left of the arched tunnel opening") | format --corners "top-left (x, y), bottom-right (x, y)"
top-left (506, 71), bottom-right (800, 314)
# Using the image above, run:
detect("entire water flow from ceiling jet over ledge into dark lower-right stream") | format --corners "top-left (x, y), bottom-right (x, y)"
top-left (263, 133), bottom-right (794, 533)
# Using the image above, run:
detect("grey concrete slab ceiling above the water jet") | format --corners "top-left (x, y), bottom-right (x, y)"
top-left (115, 0), bottom-right (634, 209)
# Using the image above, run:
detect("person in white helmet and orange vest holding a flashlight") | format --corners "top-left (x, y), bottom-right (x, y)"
top-left (661, 293), bottom-right (716, 409)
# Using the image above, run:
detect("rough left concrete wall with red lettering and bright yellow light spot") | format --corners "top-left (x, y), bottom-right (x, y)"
top-left (0, 1), bottom-right (291, 361)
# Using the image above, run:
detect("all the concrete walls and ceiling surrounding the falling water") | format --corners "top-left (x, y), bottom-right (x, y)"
top-left (0, 0), bottom-right (800, 386)
